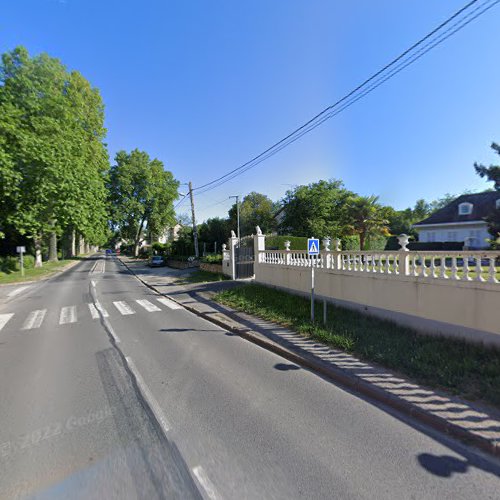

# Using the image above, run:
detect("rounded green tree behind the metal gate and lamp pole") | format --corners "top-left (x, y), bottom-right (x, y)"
top-left (229, 191), bottom-right (277, 236)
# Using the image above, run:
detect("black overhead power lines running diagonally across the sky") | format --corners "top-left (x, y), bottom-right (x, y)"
top-left (194, 0), bottom-right (500, 194)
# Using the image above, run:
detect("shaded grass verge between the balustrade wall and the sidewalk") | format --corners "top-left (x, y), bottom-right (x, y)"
top-left (215, 284), bottom-right (500, 408)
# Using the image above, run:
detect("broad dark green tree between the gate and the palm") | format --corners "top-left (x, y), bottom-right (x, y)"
top-left (280, 180), bottom-right (355, 237)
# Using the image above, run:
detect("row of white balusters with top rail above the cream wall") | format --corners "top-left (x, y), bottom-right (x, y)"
top-left (259, 250), bottom-right (500, 284)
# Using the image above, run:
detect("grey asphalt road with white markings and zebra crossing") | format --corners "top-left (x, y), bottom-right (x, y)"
top-left (0, 257), bottom-right (500, 499)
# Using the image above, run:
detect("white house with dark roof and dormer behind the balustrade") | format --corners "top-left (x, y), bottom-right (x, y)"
top-left (413, 191), bottom-right (500, 249)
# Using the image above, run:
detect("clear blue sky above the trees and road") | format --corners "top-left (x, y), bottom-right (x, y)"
top-left (0, 0), bottom-right (500, 221)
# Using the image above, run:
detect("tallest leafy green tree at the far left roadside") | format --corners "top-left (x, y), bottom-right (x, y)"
top-left (0, 47), bottom-right (107, 266)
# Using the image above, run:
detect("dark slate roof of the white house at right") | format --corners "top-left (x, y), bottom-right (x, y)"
top-left (414, 191), bottom-right (500, 226)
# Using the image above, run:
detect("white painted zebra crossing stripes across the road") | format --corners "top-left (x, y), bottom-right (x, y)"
top-left (0, 297), bottom-right (182, 331)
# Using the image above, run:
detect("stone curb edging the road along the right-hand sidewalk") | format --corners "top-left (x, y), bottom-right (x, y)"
top-left (119, 259), bottom-right (500, 457)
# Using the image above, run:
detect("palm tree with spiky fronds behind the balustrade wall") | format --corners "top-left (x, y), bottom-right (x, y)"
top-left (348, 196), bottom-right (388, 250)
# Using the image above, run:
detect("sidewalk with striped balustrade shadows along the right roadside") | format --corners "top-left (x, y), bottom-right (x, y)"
top-left (120, 257), bottom-right (500, 456)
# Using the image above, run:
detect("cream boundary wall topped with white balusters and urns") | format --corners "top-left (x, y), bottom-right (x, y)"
top-left (254, 231), bottom-right (500, 346)
